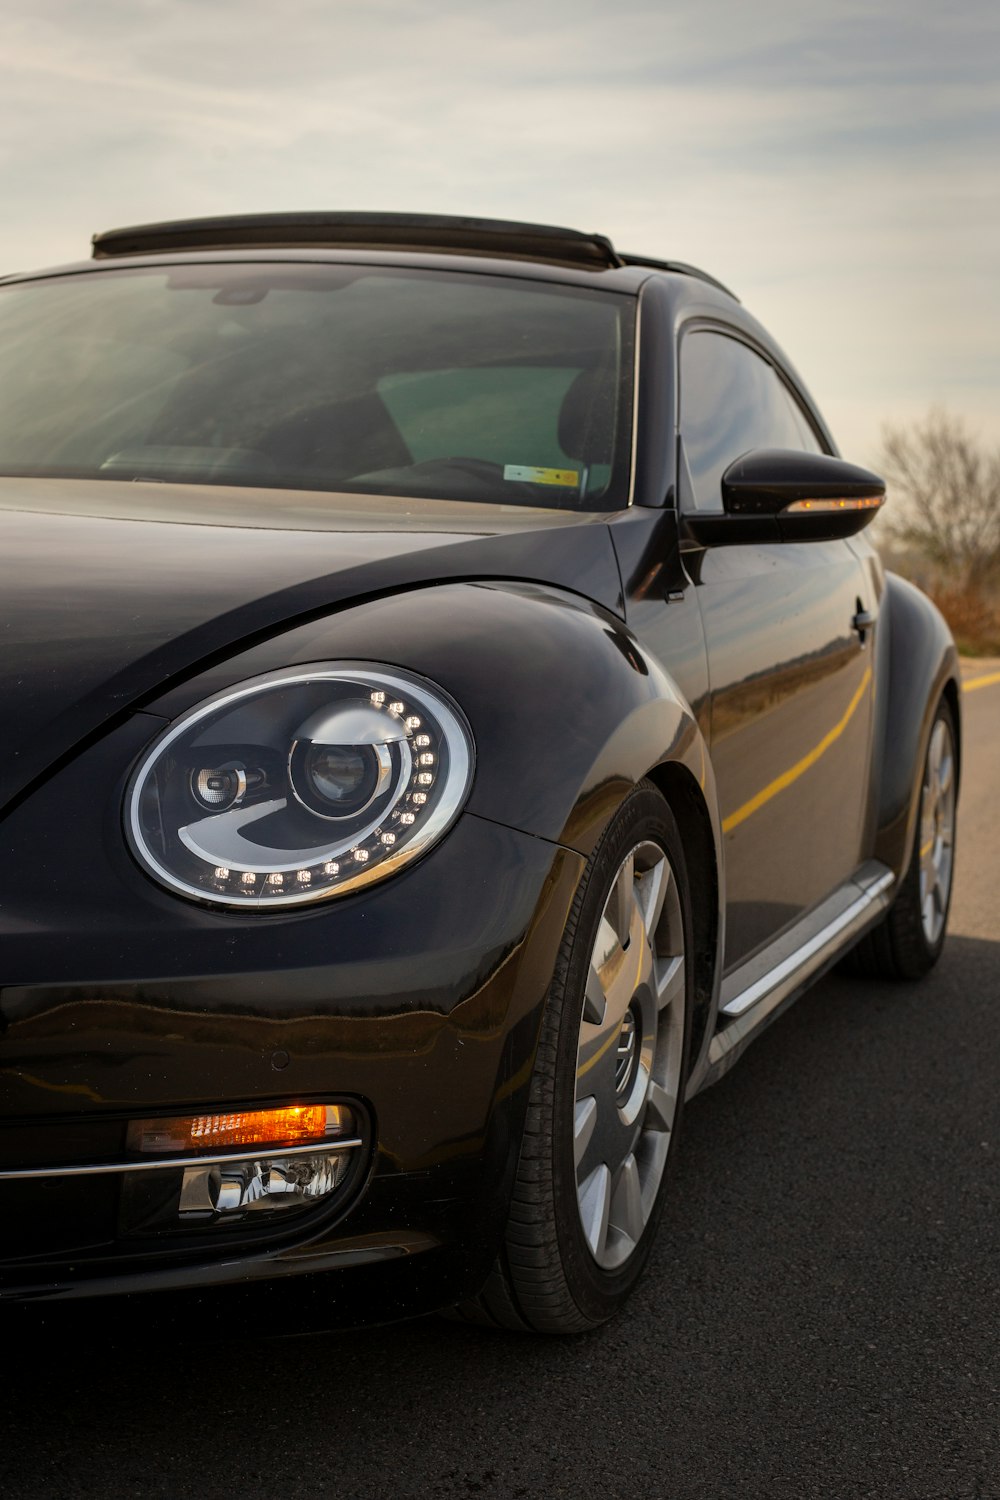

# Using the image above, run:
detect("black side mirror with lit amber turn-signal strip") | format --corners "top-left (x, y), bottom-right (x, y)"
top-left (684, 449), bottom-right (886, 546)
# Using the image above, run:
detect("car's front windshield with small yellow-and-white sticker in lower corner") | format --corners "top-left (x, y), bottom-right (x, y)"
top-left (0, 263), bottom-right (636, 510)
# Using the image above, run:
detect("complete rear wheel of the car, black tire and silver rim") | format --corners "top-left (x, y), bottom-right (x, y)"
top-left (849, 699), bottom-right (958, 980)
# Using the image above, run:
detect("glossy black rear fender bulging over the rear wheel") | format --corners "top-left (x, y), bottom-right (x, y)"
top-left (874, 573), bottom-right (961, 879)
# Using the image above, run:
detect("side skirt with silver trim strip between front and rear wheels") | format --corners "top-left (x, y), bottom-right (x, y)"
top-left (688, 860), bottom-right (895, 1098)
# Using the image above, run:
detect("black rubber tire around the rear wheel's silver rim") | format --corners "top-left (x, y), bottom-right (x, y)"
top-left (846, 698), bottom-right (958, 980)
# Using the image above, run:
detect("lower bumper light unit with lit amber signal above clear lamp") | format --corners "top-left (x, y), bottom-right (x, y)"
top-left (120, 1104), bottom-right (364, 1235)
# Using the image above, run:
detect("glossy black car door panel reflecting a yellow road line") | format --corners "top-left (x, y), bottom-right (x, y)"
top-left (699, 543), bottom-right (871, 968)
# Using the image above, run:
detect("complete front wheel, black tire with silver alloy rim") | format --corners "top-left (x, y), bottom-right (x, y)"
top-left (456, 783), bottom-right (693, 1334)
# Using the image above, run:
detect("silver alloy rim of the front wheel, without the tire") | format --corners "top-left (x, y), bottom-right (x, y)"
top-left (573, 840), bottom-right (687, 1271)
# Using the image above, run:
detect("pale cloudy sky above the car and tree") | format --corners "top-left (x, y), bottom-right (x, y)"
top-left (0, 0), bottom-right (1000, 464)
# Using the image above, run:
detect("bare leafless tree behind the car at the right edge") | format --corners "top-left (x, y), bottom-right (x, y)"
top-left (879, 407), bottom-right (1000, 597)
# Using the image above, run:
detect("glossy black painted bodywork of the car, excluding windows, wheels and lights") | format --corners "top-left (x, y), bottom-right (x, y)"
top-left (0, 251), bottom-right (957, 1322)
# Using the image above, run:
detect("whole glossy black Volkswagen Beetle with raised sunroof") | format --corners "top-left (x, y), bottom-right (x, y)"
top-left (0, 213), bottom-right (960, 1332)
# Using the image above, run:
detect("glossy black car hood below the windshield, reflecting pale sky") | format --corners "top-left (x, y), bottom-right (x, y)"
top-left (0, 479), bottom-right (621, 807)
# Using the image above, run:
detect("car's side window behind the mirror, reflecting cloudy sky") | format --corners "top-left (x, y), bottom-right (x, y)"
top-left (681, 330), bottom-right (823, 510)
